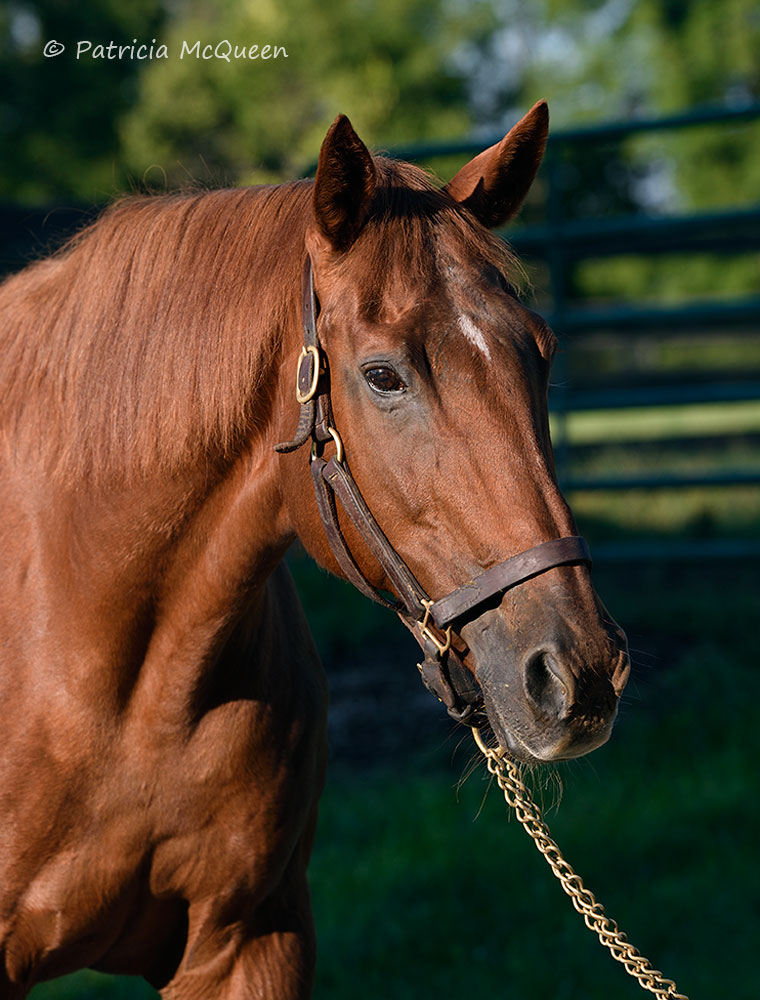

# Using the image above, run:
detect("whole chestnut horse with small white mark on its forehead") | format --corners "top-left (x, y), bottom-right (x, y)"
top-left (0, 103), bottom-right (627, 1000)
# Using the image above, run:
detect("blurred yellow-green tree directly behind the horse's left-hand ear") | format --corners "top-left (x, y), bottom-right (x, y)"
top-left (116, 0), bottom-right (484, 183)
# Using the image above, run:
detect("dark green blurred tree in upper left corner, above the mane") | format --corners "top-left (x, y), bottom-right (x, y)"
top-left (0, 0), bottom-right (165, 204)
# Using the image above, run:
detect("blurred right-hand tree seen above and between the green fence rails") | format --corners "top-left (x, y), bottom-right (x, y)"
top-left (472, 0), bottom-right (760, 301)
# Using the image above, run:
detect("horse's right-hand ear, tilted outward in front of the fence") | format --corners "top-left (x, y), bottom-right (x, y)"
top-left (446, 101), bottom-right (549, 229)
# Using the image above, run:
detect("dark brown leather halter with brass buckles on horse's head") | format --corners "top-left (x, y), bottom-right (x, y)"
top-left (275, 254), bottom-right (591, 725)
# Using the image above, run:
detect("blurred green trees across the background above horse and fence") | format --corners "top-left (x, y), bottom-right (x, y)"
top-left (0, 0), bottom-right (760, 208)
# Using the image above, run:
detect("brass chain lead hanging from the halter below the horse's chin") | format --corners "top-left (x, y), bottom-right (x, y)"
top-left (472, 729), bottom-right (688, 1000)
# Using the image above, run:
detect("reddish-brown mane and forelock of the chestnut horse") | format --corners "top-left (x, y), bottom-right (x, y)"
top-left (0, 158), bottom-right (516, 483)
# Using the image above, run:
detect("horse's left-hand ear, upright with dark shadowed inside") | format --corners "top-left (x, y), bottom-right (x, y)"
top-left (314, 115), bottom-right (375, 250)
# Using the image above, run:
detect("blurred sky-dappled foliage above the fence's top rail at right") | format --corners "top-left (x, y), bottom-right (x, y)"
top-left (498, 0), bottom-right (760, 131)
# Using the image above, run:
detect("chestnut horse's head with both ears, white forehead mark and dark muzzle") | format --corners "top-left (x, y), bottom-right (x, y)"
top-left (282, 102), bottom-right (628, 761)
